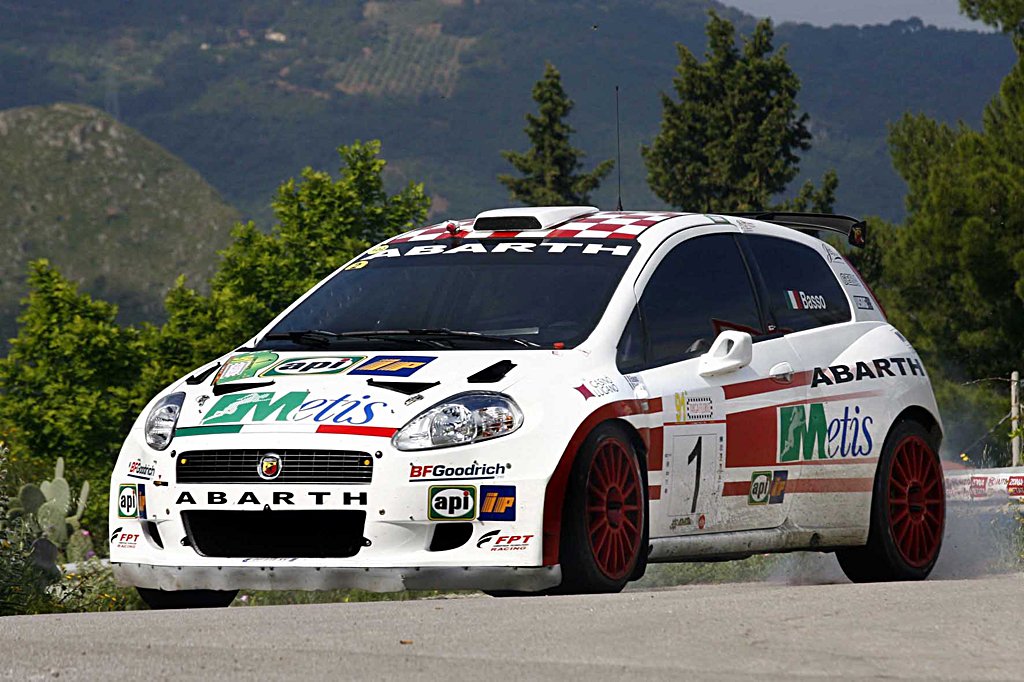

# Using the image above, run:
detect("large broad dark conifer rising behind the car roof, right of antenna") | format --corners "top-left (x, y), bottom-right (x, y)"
top-left (641, 11), bottom-right (838, 212)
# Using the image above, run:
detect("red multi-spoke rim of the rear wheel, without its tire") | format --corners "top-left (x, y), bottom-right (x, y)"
top-left (889, 435), bottom-right (945, 568)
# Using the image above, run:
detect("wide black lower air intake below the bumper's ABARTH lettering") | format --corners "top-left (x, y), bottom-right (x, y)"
top-left (181, 510), bottom-right (367, 559)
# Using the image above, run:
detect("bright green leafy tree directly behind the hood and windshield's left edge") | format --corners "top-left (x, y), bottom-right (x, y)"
top-left (144, 140), bottom-right (430, 388)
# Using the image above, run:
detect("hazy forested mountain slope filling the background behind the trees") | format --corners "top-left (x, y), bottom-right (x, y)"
top-left (0, 0), bottom-right (1015, 246)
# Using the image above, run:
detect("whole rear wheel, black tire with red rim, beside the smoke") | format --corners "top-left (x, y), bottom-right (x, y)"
top-left (836, 421), bottom-right (945, 583)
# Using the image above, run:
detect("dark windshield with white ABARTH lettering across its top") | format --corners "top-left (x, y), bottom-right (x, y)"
top-left (259, 240), bottom-right (639, 350)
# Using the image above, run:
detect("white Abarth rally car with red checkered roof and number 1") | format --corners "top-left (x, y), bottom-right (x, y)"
top-left (110, 202), bottom-right (945, 607)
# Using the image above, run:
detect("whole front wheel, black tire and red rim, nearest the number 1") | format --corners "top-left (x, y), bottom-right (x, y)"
top-left (555, 423), bottom-right (647, 594)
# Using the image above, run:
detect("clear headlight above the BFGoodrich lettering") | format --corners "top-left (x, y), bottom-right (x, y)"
top-left (391, 392), bottom-right (522, 450)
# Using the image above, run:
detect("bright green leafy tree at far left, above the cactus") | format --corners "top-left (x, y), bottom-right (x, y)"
top-left (0, 260), bottom-right (144, 530)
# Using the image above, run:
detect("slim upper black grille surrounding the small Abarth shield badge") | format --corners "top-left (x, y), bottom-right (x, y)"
top-left (176, 450), bottom-right (374, 484)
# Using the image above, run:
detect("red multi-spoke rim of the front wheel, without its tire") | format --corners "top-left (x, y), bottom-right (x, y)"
top-left (587, 438), bottom-right (644, 581)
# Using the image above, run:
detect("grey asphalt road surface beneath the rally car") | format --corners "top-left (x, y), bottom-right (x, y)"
top-left (0, 576), bottom-right (1024, 682)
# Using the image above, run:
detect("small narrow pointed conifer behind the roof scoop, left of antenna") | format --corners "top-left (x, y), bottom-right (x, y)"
top-left (498, 62), bottom-right (615, 206)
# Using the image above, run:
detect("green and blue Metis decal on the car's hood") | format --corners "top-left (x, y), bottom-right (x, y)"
top-left (202, 391), bottom-right (387, 426)
